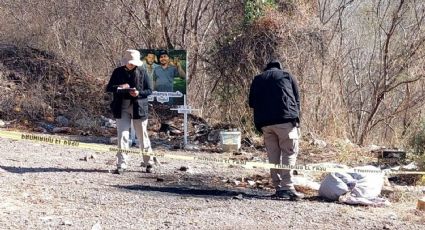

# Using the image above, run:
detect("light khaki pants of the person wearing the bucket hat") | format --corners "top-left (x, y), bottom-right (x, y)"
top-left (117, 100), bottom-right (154, 169)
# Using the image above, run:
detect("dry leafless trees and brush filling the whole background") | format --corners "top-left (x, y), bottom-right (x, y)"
top-left (0, 0), bottom-right (425, 149)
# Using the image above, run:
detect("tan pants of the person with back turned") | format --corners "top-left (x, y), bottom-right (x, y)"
top-left (262, 123), bottom-right (299, 190)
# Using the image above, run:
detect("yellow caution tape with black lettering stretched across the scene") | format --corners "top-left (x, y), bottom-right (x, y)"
top-left (0, 130), bottom-right (425, 175)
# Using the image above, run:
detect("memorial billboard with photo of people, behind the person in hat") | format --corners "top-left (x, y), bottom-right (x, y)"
top-left (139, 49), bottom-right (187, 105)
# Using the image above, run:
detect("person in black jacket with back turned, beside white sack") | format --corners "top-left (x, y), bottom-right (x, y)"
top-left (249, 60), bottom-right (304, 200)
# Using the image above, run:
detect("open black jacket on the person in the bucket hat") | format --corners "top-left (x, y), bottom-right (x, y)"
top-left (106, 66), bottom-right (152, 120)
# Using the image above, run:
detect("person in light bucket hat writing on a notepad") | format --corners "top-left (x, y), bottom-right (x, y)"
top-left (106, 49), bottom-right (156, 174)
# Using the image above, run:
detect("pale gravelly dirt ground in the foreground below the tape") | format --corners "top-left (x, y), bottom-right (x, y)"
top-left (0, 133), bottom-right (425, 230)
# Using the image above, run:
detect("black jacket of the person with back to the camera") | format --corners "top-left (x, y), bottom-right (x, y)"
top-left (249, 61), bottom-right (300, 132)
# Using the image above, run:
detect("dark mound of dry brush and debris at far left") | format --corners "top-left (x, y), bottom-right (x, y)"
top-left (0, 44), bottom-right (107, 133)
